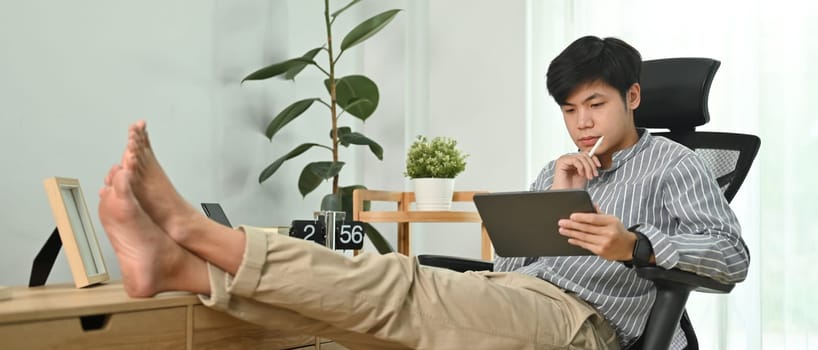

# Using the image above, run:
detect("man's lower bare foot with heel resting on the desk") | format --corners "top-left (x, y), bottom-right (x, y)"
top-left (99, 166), bottom-right (210, 297)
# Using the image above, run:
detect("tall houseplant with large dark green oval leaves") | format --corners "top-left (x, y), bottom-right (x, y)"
top-left (242, 0), bottom-right (400, 253)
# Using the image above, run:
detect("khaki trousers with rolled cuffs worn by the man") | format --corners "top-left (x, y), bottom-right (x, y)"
top-left (202, 227), bottom-right (619, 349)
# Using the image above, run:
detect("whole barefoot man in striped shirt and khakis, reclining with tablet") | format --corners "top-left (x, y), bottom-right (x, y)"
top-left (99, 37), bottom-right (747, 349)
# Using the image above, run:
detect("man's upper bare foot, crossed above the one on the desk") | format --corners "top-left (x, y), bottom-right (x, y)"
top-left (122, 121), bottom-right (208, 244)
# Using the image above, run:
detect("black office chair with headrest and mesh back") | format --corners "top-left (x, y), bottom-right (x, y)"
top-left (418, 58), bottom-right (761, 350)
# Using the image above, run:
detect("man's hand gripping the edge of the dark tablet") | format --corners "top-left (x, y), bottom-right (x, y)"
top-left (559, 209), bottom-right (636, 261)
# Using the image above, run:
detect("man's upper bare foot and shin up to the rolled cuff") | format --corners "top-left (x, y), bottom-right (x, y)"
top-left (122, 121), bottom-right (245, 275)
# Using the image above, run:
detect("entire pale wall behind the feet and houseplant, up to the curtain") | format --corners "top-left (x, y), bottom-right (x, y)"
top-left (0, 0), bottom-right (532, 285)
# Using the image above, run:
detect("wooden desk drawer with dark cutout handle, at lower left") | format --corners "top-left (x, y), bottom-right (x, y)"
top-left (0, 307), bottom-right (187, 349)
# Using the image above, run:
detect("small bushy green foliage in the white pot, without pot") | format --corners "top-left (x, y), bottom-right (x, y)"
top-left (404, 136), bottom-right (468, 179)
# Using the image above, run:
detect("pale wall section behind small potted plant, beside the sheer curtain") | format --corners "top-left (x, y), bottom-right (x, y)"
top-left (409, 1), bottom-right (528, 258)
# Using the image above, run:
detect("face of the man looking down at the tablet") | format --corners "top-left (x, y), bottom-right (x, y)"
top-left (561, 81), bottom-right (640, 168)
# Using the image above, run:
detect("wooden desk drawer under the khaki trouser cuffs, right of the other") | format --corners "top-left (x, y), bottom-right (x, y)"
top-left (193, 305), bottom-right (316, 350)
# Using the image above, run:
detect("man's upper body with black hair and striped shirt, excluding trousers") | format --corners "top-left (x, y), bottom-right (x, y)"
top-left (495, 37), bottom-right (749, 349)
